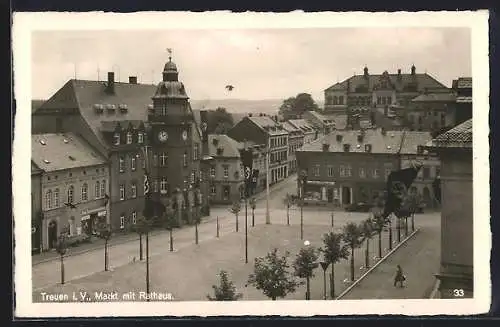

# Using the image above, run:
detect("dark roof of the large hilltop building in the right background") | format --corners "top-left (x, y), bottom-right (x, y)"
top-left (325, 73), bottom-right (446, 92)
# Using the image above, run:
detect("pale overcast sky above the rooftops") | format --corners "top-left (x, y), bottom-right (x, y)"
top-left (32, 28), bottom-right (472, 100)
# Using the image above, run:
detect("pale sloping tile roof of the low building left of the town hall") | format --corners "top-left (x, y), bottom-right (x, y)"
top-left (31, 133), bottom-right (106, 171)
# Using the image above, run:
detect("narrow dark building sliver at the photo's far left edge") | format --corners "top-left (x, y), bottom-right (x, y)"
top-left (31, 161), bottom-right (42, 253)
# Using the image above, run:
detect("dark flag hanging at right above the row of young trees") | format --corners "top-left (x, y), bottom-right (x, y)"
top-left (383, 164), bottom-right (422, 218)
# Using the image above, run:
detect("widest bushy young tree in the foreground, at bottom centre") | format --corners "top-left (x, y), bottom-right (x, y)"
top-left (248, 249), bottom-right (300, 301)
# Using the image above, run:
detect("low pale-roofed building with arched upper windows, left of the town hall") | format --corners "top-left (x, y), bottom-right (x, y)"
top-left (31, 133), bottom-right (109, 250)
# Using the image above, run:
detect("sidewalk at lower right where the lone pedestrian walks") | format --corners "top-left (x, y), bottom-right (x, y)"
top-left (342, 228), bottom-right (441, 300)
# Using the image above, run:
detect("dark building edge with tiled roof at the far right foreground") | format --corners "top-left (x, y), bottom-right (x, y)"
top-left (427, 119), bottom-right (474, 299)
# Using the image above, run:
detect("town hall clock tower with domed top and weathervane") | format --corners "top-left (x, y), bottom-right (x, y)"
top-left (147, 53), bottom-right (201, 224)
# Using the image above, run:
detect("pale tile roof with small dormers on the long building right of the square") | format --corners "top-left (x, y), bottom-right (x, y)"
top-left (297, 129), bottom-right (403, 154)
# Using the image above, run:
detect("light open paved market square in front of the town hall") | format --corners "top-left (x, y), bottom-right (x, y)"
top-left (33, 173), bottom-right (439, 300)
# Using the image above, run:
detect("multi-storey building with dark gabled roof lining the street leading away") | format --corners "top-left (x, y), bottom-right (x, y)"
top-left (227, 115), bottom-right (288, 184)
